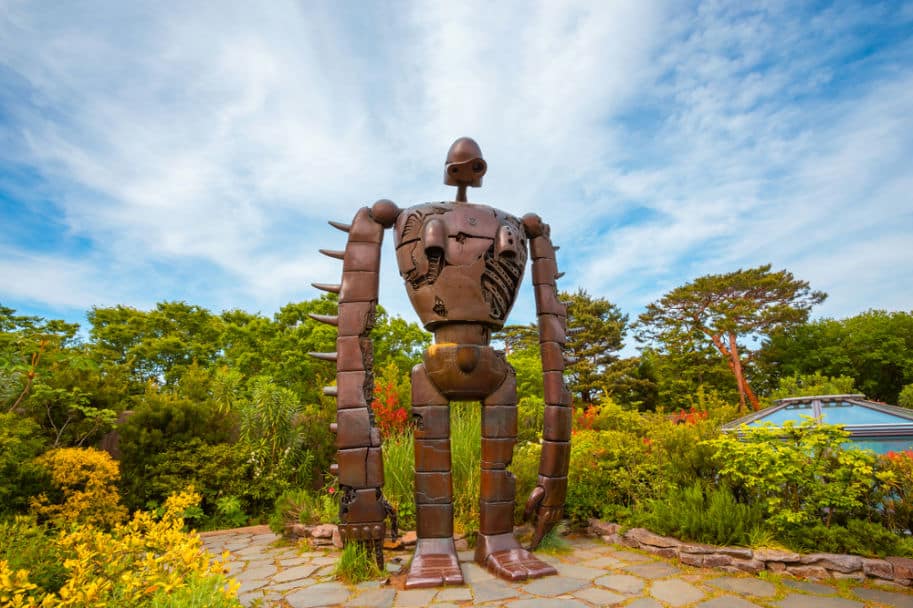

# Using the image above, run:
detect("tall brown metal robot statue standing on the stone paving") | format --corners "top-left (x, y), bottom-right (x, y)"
top-left (311, 138), bottom-right (571, 588)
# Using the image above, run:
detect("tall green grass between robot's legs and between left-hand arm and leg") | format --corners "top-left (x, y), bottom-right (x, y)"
top-left (384, 403), bottom-right (482, 534)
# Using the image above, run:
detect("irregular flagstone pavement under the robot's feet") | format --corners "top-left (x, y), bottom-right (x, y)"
top-left (201, 526), bottom-right (913, 608)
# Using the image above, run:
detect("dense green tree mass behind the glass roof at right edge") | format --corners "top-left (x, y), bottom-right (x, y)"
top-left (758, 310), bottom-right (913, 403)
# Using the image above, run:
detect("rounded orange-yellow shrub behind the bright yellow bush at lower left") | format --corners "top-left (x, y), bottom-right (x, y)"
top-left (30, 448), bottom-right (127, 528)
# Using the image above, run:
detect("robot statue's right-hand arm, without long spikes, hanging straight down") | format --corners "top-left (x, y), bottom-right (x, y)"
top-left (523, 214), bottom-right (572, 549)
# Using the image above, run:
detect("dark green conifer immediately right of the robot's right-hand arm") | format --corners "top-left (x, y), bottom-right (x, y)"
top-left (560, 289), bottom-right (628, 403)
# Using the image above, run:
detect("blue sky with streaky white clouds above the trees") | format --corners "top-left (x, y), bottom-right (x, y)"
top-left (0, 0), bottom-right (913, 341)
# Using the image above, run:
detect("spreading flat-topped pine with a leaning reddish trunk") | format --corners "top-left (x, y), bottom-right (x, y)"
top-left (639, 264), bottom-right (827, 410)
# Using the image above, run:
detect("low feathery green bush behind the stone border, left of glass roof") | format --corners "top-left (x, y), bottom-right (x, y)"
top-left (634, 483), bottom-right (764, 545)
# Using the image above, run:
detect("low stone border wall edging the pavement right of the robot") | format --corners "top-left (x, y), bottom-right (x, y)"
top-left (587, 519), bottom-right (913, 587)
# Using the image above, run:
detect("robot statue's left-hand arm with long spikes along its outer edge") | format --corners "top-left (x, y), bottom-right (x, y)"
top-left (310, 200), bottom-right (399, 565)
